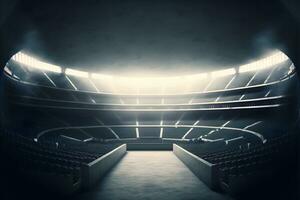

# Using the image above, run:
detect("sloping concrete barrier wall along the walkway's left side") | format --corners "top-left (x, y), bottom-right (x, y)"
top-left (81, 144), bottom-right (126, 189)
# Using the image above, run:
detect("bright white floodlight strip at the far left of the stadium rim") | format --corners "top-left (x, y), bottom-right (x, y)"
top-left (12, 52), bottom-right (62, 73)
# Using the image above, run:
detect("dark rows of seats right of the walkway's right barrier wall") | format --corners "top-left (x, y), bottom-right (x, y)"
top-left (181, 135), bottom-right (295, 194)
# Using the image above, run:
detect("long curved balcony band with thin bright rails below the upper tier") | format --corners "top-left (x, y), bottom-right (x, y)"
top-left (11, 96), bottom-right (292, 112)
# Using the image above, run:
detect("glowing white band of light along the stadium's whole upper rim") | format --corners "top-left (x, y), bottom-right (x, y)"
top-left (5, 51), bottom-right (294, 95)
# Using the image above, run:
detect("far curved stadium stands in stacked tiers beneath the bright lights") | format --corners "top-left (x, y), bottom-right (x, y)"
top-left (5, 50), bottom-right (296, 142)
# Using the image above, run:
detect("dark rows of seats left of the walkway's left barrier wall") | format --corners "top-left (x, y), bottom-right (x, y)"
top-left (1, 131), bottom-right (119, 192)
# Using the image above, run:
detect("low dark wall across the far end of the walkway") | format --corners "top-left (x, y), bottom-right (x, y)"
top-left (127, 143), bottom-right (173, 151)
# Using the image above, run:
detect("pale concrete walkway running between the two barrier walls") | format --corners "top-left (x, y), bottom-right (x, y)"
top-left (78, 151), bottom-right (229, 200)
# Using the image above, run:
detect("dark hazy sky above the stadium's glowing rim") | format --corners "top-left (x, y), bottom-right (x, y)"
top-left (19, 0), bottom-right (296, 73)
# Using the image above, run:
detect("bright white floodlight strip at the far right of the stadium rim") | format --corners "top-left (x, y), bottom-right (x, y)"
top-left (239, 51), bottom-right (289, 73)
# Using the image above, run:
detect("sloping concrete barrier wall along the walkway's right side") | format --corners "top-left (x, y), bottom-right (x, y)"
top-left (173, 144), bottom-right (219, 189)
